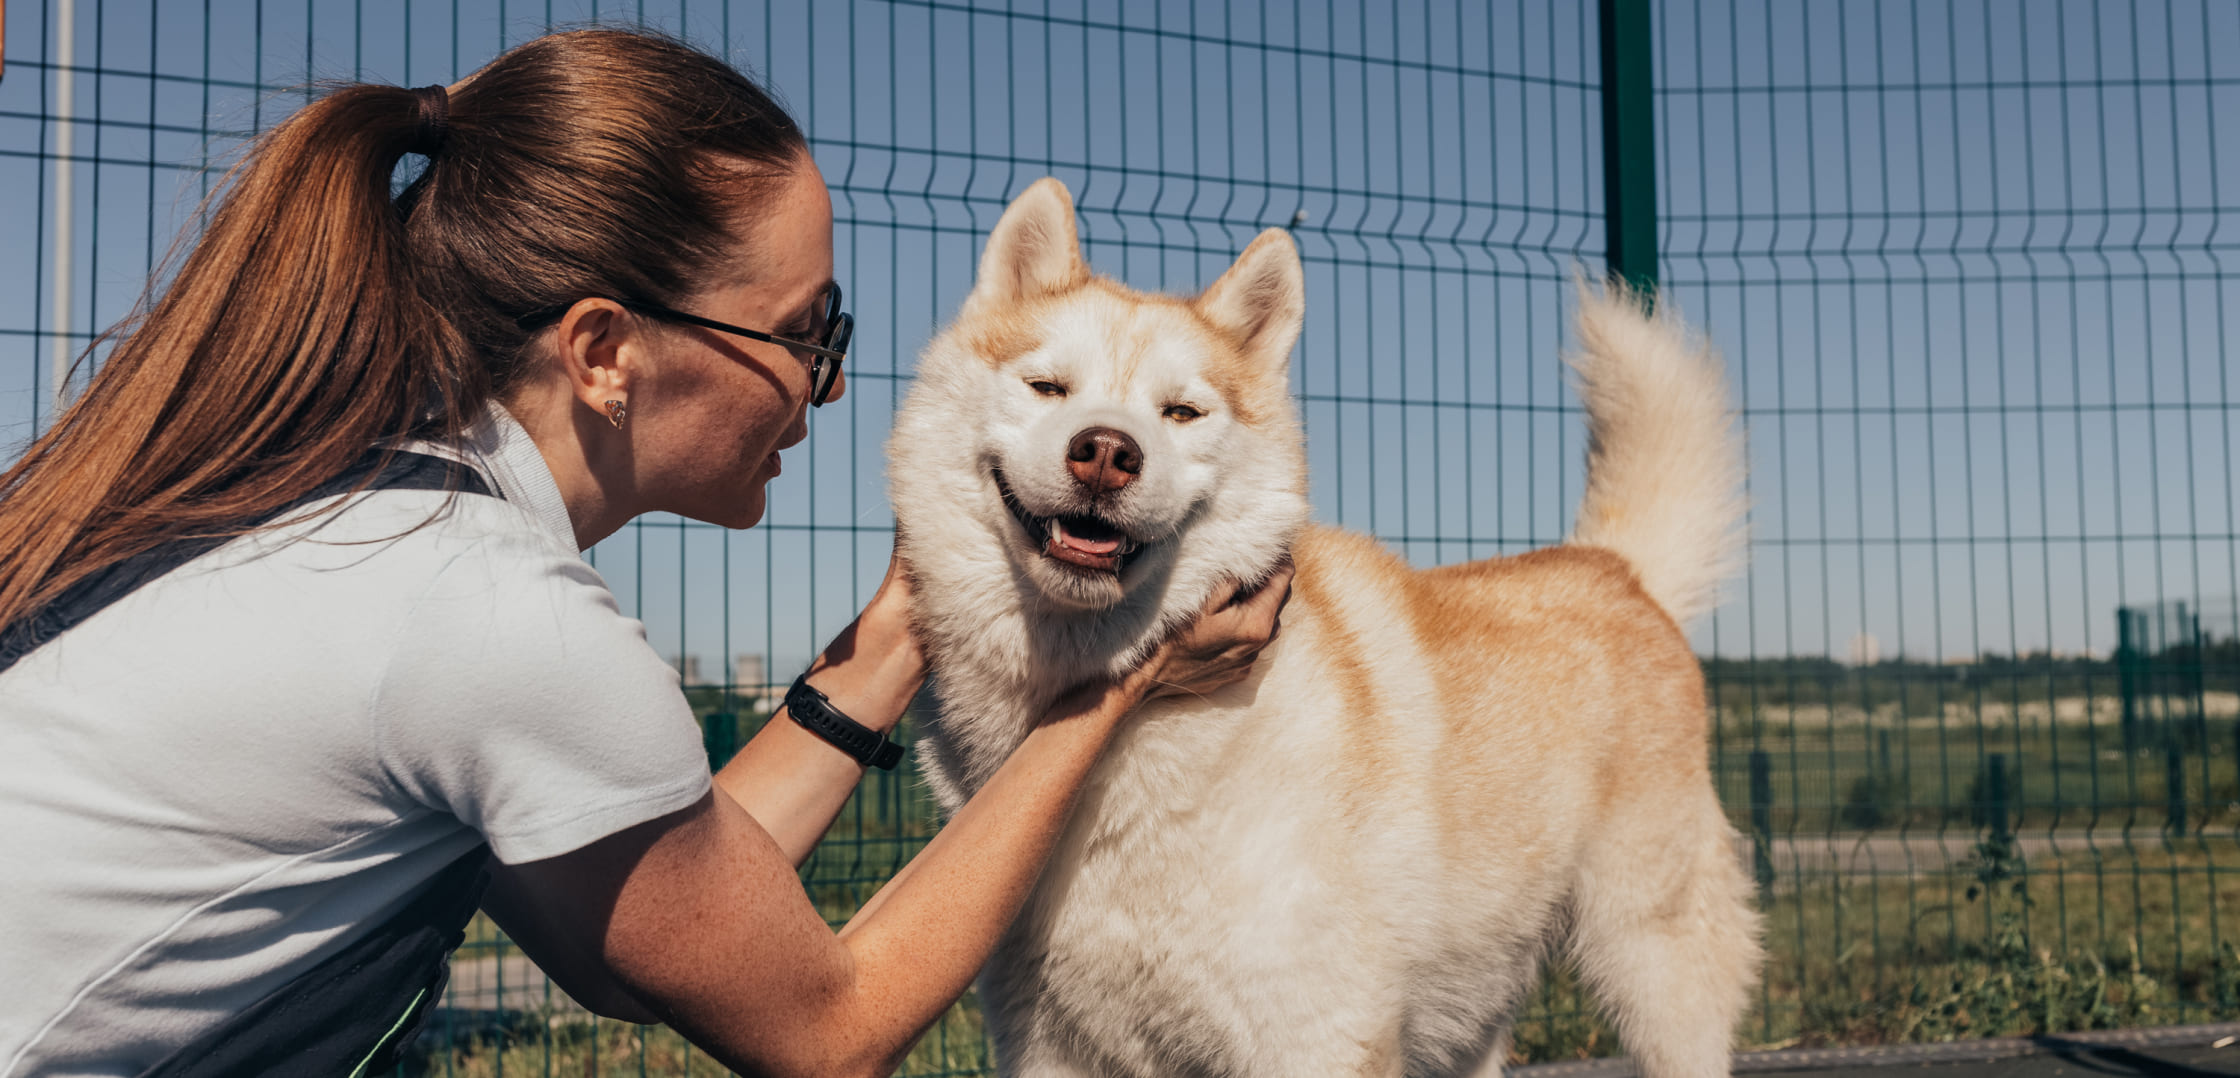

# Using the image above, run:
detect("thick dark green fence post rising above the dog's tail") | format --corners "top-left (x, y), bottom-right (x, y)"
top-left (1602, 0), bottom-right (1658, 296)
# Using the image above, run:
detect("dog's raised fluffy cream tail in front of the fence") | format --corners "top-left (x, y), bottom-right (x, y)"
top-left (1570, 285), bottom-right (1749, 625)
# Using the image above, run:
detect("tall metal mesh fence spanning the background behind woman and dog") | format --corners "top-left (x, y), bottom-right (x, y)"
top-left (0, 0), bottom-right (2240, 1076)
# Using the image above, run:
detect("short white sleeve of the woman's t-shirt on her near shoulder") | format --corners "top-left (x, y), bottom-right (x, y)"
top-left (374, 528), bottom-right (710, 865)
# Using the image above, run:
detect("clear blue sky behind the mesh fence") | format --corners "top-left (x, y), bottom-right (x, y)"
top-left (0, 0), bottom-right (2240, 675)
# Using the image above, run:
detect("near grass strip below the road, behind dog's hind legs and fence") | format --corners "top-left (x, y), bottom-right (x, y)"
top-left (1514, 836), bottom-right (2240, 1062)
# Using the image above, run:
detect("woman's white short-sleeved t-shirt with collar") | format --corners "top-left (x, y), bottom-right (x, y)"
top-left (0, 406), bottom-right (710, 1078)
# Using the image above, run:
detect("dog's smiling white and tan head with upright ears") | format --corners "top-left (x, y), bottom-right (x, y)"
top-left (887, 179), bottom-right (1306, 610)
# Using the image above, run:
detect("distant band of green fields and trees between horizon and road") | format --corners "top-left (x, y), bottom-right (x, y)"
top-left (1705, 639), bottom-right (2240, 840)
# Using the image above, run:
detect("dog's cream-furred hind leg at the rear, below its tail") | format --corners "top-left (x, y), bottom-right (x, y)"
top-left (1572, 791), bottom-right (1758, 1078)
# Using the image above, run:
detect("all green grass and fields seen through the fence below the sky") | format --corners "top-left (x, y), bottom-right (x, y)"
top-left (405, 675), bottom-right (2240, 1078)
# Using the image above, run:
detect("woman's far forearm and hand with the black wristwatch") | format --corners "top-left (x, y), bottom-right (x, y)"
top-left (715, 560), bottom-right (925, 867)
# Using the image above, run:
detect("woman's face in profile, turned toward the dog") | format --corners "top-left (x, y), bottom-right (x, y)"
top-left (629, 155), bottom-right (847, 529)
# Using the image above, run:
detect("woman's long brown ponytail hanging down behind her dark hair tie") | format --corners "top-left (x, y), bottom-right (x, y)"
top-left (0, 85), bottom-right (464, 625)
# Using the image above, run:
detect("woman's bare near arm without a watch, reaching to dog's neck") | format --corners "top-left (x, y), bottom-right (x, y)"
top-left (490, 562), bottom-right (1284, 1076)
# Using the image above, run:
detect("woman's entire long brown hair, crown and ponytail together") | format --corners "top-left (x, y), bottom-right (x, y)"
top-left (0, 29), bottom-right (806, 628)
